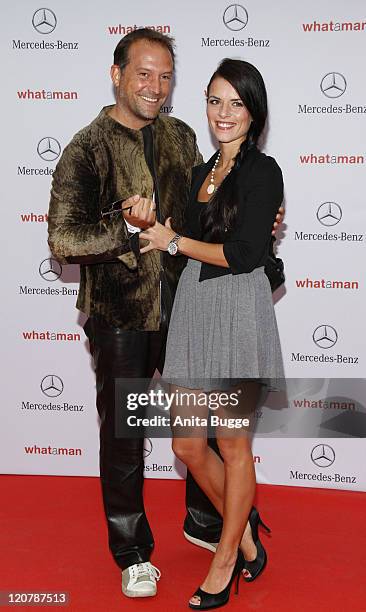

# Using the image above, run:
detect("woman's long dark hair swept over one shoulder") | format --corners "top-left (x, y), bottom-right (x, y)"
top-left (201, 59), bottom-right (267, 242)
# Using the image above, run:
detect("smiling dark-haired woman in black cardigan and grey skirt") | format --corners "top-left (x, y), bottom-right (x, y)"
top-left (140, 59), bottom-right (283, 610)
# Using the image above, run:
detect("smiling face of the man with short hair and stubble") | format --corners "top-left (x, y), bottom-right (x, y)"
top-left (111, 40), bottom-right (173, 129)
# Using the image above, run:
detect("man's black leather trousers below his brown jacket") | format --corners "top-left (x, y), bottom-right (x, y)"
top-left (84, 317), bottom-right (221, 569)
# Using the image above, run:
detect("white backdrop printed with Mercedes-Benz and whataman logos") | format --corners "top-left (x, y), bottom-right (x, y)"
top-left (0, 0), bottom-right (366, 490)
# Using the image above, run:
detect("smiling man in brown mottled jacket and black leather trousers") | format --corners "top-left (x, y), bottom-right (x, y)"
top-left (49, 29), bottom-right (284, 597)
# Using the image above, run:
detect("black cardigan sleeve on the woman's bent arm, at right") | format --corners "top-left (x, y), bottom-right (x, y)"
top-left (223, 157), bottom-right (283, 274)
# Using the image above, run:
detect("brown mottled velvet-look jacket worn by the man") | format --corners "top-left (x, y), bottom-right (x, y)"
top-left (48, 107), bottom-right (202, 331)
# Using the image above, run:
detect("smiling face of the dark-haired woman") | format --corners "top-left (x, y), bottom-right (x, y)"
top-left (207, 76), bottom-right (252, 147)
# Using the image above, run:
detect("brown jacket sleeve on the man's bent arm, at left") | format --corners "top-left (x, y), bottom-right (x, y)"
top-left (48, 139), bottom-right (137, 267)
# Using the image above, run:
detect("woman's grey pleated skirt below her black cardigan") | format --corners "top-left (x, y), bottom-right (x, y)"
top-left (163, 259), bottom-right (284, 390)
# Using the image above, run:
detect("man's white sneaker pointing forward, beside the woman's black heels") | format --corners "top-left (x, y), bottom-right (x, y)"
top-left (122, 561), bottom-right (161, 597)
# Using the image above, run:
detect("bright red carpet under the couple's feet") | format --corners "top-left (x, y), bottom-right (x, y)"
top-left (0, 476), bottom-right (366, 612)
